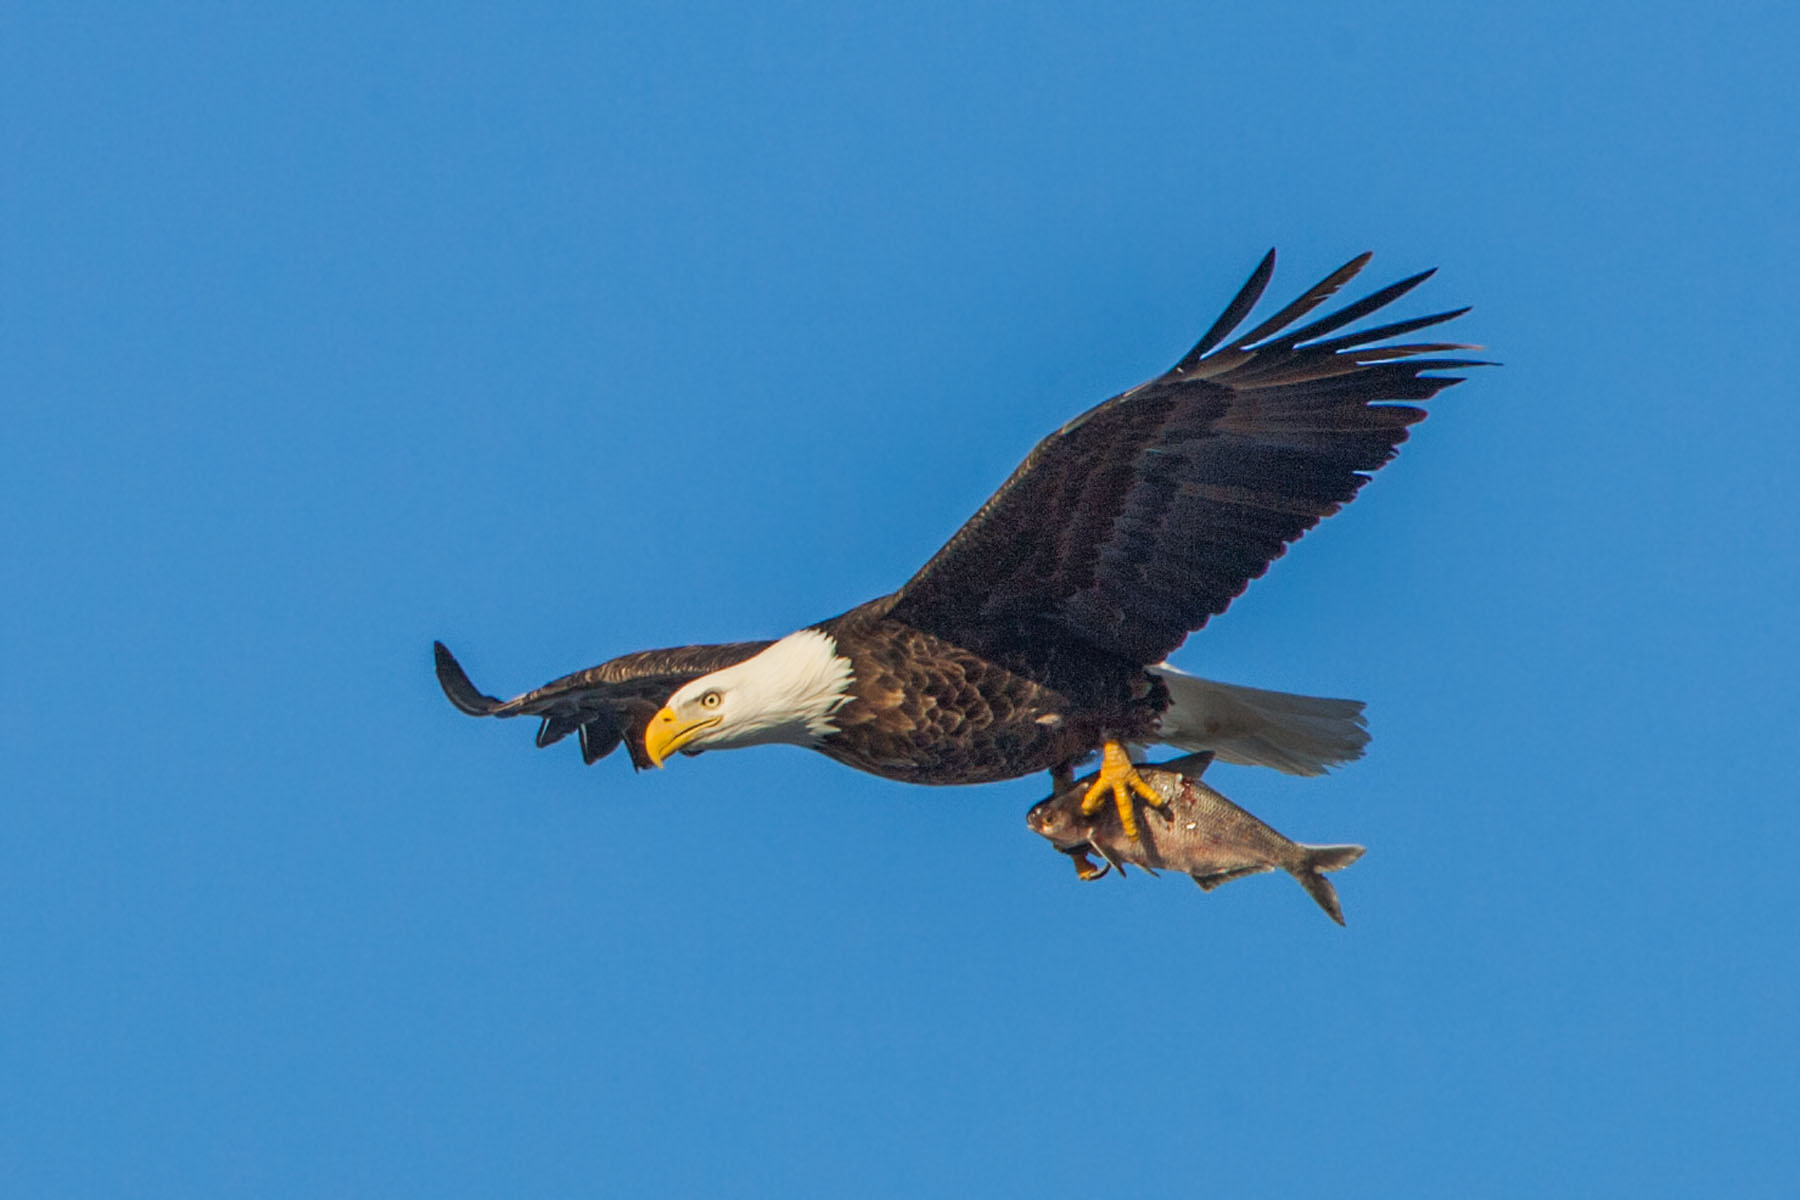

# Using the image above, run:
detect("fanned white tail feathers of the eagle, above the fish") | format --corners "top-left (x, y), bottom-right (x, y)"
top-left (1150, 666), bottom-right (1368, 775)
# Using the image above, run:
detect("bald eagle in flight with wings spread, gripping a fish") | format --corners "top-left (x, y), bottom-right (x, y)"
top-left (436, 250), bottom-right (1485, 837)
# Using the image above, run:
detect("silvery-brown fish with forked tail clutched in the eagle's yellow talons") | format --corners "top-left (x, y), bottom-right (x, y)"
top-left (1024, 754), bottom-right (1364, 925)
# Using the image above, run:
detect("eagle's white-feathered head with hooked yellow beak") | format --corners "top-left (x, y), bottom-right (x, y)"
top-left (644, 630), bottom-right (851, 766)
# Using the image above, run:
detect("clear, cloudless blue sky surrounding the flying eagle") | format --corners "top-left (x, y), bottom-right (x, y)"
top-left (0, 4), bottom-right (1800, 1196)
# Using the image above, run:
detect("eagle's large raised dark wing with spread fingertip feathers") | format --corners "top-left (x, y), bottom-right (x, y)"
top-left (891, 250), bottom-right (1485, 664)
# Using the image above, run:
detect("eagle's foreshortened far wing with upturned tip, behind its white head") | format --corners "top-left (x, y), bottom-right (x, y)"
top-left (442, 642), bottom-right (769, 768)
